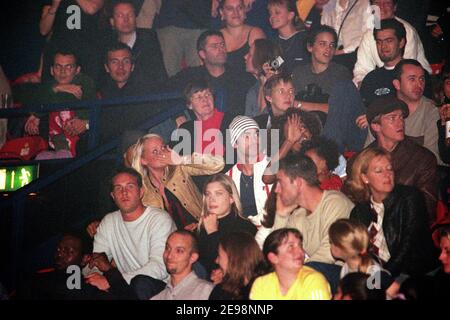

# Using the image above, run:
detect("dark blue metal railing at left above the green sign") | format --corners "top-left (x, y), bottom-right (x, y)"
top-left (0, 93), bottom-right (186, 285)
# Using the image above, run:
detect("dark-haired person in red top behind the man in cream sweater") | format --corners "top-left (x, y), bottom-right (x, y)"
top-left (302, 137), bottom-right (345, 191)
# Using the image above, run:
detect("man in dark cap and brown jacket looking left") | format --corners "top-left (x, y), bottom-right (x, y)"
top-left (367, 96), bottom-right (438, 224)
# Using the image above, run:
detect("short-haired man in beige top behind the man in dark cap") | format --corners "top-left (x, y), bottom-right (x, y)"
top-left (366, 59), bottom-right (442, 163)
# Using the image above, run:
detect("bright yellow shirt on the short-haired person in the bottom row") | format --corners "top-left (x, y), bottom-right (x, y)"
top-left (250, 266), bottom-right (331, 300)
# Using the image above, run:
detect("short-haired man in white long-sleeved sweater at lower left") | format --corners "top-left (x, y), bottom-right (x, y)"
top-left (88, 168), bottom-right (176, 296)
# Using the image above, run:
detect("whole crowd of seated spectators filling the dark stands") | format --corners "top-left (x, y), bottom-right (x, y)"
top-left (0, 0), bottom-right (450, 300)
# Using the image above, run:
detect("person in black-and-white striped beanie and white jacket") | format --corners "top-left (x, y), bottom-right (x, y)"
top-left (227, 116), bottom-right (272, 246)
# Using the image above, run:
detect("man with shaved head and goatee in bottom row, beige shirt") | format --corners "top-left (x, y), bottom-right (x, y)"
top-left (151, 230), bottom-right (214, 300)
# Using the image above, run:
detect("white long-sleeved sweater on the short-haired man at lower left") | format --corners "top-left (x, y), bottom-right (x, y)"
top-left (93, 207), bottom-right (176, 283)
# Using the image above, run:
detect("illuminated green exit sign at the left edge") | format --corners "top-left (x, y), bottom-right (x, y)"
top-left (0, 165), bottom-right (39, 192)
